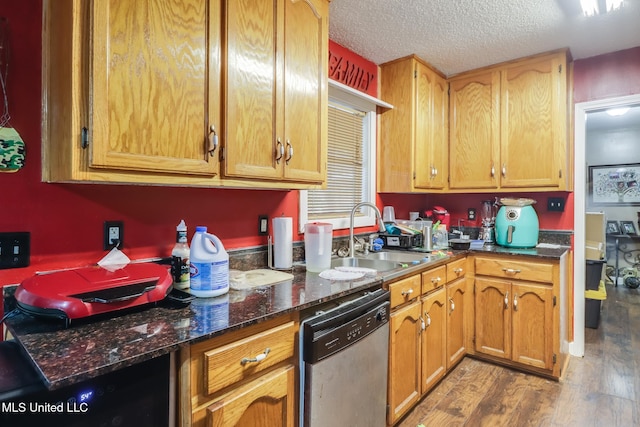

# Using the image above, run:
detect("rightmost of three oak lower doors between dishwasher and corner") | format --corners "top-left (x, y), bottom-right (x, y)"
top-left (447, 278), bottom-right (473, 369)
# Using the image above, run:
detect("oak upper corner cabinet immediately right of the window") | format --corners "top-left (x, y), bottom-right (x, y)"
top-left (378, 56), bottom-right (449, 192)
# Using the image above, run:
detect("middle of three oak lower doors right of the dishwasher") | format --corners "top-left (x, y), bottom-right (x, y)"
top-left (421, 288), bottom-right (447, 394)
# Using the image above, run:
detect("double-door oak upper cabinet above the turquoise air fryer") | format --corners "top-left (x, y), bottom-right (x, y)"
top-left (449, 50), bottom-right (571, 191)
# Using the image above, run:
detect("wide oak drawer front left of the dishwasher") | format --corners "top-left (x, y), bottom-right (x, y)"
top-left (204, 322), bottom-right (295, 394)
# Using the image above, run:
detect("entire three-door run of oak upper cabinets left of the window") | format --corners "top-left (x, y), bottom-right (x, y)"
top-left (42, 0), bottom-right (328, 189)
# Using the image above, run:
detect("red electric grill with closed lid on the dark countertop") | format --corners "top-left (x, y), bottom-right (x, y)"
top-left (15, 263), bottom-right (173, 326)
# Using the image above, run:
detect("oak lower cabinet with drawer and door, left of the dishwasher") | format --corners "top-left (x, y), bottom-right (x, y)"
top-left (178, 315), bottom-right (298, 427)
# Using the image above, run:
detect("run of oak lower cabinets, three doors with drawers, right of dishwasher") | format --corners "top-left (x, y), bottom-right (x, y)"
top-left (387, 258), bottom-right (473, 425)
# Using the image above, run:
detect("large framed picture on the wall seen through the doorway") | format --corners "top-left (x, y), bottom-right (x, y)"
top-left (589, 163), bottom-right (640, 206)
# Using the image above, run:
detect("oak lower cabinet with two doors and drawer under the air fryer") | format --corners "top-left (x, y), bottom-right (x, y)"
top-left (474, 254), bottom-right (570, 378)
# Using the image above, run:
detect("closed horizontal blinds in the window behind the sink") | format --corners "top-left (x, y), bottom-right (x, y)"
top-left (307, 103), bottom-right (371, 221)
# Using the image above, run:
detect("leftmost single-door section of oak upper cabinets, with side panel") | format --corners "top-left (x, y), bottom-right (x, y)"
top-left (43, 0), bottom-right (220, 184)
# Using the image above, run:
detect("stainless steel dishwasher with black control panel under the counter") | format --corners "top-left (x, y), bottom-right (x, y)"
top-left (300, 289), bottom-right (389, 427)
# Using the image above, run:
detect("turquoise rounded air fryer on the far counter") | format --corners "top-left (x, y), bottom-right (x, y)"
top-left (496, 198), bottom-right (540, 248)
